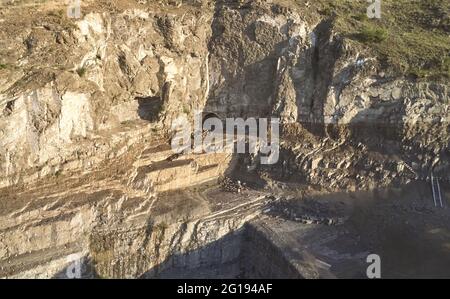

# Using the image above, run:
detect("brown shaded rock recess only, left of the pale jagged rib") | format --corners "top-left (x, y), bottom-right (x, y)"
top-left (205, 1), bottom-right (288, 119)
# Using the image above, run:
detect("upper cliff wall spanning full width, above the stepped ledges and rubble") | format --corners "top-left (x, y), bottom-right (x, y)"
top-left (0, 1), bottom-right (450, 186)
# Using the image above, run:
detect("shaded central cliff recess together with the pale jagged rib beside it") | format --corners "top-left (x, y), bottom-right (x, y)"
top-left (206, 2), bottom-right (339, 123)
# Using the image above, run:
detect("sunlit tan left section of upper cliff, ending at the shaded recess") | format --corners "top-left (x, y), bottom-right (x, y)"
top-left (0, 0), bottom-right (214, 190)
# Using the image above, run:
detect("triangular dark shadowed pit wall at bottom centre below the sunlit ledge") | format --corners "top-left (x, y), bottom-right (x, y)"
top-left (140, 225), bottom-right (300, 279)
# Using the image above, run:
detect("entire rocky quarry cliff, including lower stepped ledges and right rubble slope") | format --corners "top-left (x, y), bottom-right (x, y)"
top-left (0, 0), bottom-right (450, 277)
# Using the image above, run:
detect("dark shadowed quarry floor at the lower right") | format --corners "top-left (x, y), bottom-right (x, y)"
top-left (269, 182), bottom-right (450, 278)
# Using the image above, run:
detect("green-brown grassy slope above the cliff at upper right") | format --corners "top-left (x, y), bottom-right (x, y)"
top-left (317, 0), bottom-right (450, 79)
